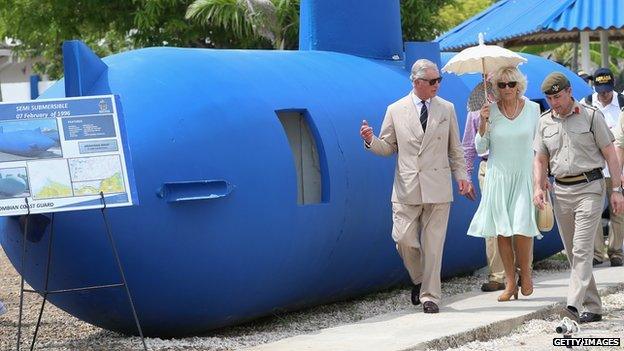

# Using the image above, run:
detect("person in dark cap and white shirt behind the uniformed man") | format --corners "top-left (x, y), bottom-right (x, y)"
top-left (581, 68), bottom-right (624, 267)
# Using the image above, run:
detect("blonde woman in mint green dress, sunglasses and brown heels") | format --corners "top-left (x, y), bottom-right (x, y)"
top-left (468, 67), bottom-right (541, 301)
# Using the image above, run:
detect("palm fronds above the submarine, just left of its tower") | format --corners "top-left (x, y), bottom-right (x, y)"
top-left (186, 0), bottom-right (299, 50)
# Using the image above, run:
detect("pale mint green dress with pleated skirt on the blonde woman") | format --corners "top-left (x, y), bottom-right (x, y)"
top-left (468, 99), bottom-right (541, 238)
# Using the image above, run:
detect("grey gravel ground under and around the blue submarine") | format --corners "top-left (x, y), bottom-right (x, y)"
top-left (0, 249), bottom-right (600, 351)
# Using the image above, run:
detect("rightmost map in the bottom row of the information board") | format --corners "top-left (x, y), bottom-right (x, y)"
top-left (69, 155), bottom-right (126, 196)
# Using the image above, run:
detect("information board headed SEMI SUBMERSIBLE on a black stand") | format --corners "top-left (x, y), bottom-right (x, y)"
top-left (0, 95), bottom-right (137, 216)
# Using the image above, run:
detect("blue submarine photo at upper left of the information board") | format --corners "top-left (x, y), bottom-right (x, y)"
top-left (0, 118), bottom-right (63, 162)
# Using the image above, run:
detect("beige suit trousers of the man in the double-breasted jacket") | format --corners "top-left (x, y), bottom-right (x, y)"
top-left (392, 202), bottom-right (451, 304)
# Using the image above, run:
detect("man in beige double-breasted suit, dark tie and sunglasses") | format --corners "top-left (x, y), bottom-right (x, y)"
top-left (360, 59), bottom-right (471, 313)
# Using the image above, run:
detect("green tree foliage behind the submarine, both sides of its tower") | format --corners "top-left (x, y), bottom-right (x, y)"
top-left (0, 0), bottom-right (491, 79)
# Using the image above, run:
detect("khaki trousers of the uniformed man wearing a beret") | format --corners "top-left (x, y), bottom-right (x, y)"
top-left (553, 179), bottom-right (605, 314)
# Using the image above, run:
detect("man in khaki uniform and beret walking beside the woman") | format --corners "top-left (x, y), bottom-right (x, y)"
top-left (533, 72), bottom-right (624, 323)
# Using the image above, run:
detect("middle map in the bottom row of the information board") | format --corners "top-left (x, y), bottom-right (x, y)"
top-left (27, 160), bottom-right (73, 199)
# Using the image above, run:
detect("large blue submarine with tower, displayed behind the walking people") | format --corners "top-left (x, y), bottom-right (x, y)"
top-left (0, 0), bottom-right (590, 337)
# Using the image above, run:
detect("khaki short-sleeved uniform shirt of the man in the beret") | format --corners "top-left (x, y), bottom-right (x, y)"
top-left (533, 101), bottom-right (614, 178)
